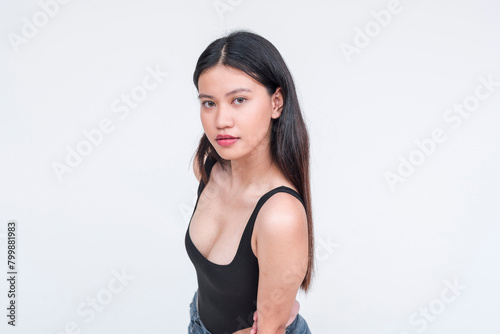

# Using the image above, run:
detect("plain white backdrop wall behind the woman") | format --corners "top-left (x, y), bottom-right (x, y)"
top-left (0, 0), bottom-right (500, 334)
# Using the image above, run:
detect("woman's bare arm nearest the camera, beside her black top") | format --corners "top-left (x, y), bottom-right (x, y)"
top-left (257, 193), bottom-right (308, 334)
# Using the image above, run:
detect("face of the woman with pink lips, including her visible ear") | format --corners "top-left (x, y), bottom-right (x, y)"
top-left (198, 65), bottom-right (283, 160)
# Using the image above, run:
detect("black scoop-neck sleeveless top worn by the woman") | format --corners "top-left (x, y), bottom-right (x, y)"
top-left (185, 158), bottom-right (305, 334)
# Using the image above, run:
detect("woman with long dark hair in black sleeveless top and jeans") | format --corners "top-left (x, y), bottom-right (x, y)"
top-left (185, 31), bottom-right (314, 334)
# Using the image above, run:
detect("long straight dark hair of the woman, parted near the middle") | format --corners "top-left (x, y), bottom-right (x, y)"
top-left (189, 30), bottom-right (315, 292)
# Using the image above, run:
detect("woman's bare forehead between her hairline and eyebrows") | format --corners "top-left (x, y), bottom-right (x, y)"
top-left (198, 65), bottom-right (264, 95)
